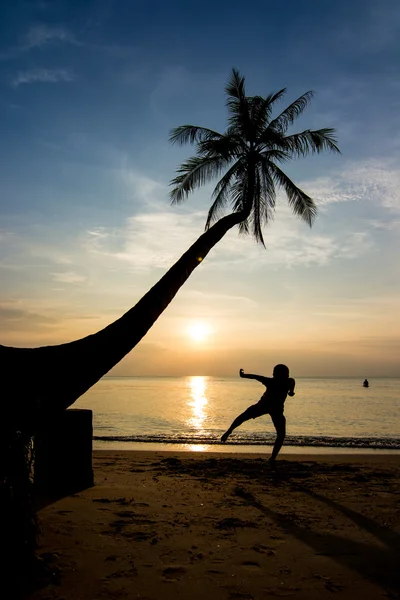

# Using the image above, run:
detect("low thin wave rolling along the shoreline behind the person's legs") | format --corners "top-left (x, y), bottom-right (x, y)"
top-left (93, 434), bottom-right (400, 450)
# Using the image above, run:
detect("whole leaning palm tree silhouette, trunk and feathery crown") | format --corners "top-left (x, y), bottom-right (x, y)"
top-left (0, 69), bottom-right (339, 431)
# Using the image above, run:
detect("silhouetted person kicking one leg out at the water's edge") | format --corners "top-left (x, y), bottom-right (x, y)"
top-left (221, 365), bottom-right (295, 461)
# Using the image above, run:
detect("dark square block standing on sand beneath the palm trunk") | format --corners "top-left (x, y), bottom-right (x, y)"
top-left (34, 409), bottom-right (94, 507)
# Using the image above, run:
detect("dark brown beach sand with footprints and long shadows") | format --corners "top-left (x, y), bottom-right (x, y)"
top-left (32, 451), bottom-right (400, 600)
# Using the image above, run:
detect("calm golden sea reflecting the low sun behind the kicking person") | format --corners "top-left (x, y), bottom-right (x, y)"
top-left (73, 376), bottom-right (400, 454)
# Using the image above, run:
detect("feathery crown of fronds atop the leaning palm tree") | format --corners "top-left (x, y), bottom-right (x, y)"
top-left (170, 69), bottom-right (340, 245)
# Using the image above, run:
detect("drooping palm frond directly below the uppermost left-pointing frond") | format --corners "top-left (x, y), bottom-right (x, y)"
top-left (170, 156), bottom-right (229, 204)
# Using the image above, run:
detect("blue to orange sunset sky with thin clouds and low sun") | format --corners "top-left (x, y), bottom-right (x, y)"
top-left (0, 0), bottom-right (400, 378)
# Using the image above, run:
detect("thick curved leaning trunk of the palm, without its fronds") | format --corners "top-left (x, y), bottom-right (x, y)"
top-left (0, 211), bottom-right (247, 432)
